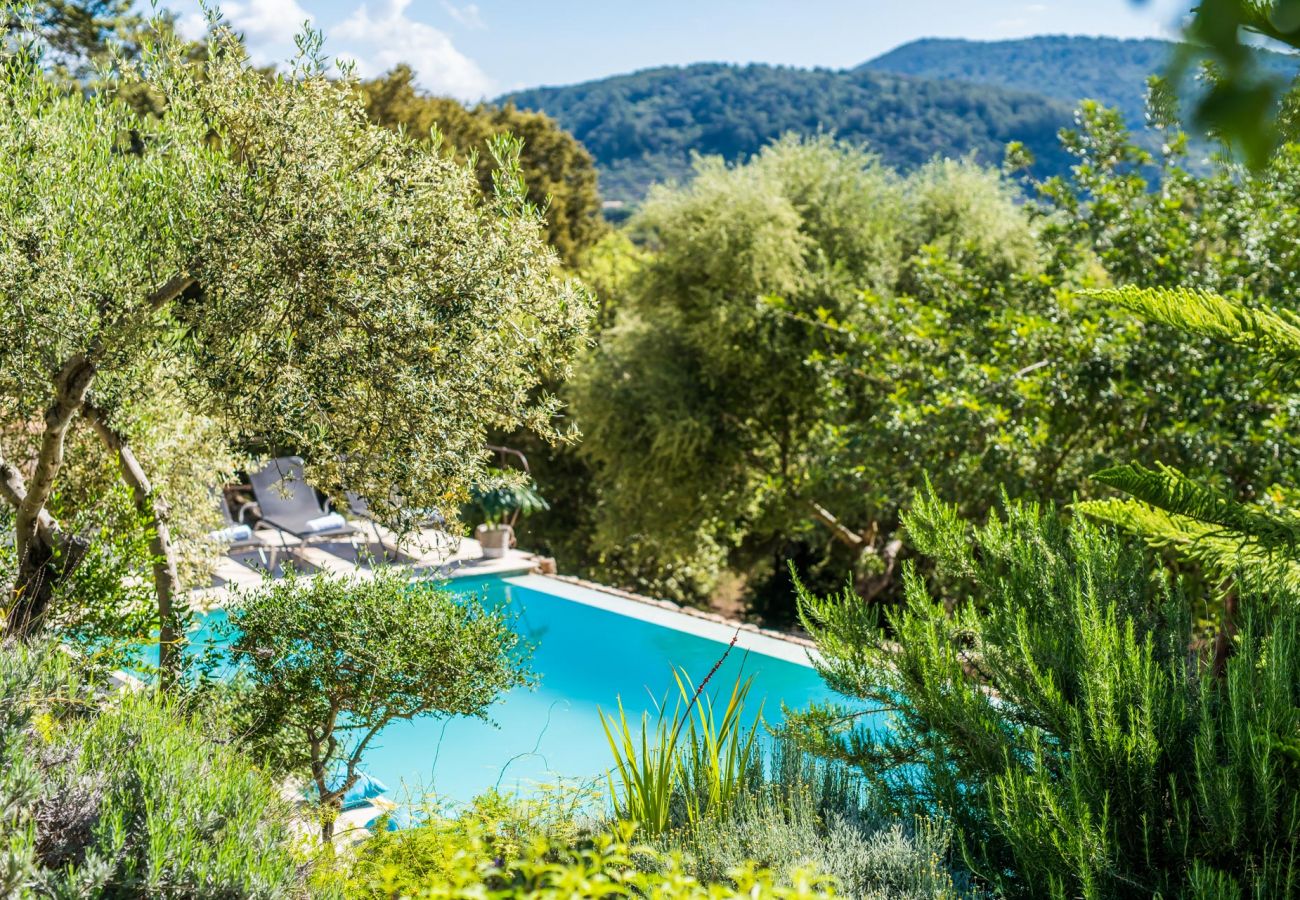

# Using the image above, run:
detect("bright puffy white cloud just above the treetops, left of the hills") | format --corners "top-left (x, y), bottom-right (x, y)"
top-left (330, 0), bottom-right (493, 100)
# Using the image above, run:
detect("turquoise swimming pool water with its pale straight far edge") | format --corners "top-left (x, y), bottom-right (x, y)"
top-left (175, 576), bottom-right (832, 801)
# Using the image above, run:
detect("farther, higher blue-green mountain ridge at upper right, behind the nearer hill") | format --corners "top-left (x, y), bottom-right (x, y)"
top-left (857, 35), bottom-right (1300, 127)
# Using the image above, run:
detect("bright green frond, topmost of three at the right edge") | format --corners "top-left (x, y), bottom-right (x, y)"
top-left (1087, 286), bottom-right (1300, 368)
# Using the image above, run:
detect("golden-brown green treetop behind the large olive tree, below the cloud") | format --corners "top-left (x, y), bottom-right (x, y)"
top-left (359, 65), bottom-right (607, 265)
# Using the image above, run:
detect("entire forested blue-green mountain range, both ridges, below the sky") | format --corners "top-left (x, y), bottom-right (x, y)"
top-left (498, 35), bottom-right (1300, 202)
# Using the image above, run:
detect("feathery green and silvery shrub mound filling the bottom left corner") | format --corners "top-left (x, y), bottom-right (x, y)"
top-left (0, 642), bottom-right (306, 899)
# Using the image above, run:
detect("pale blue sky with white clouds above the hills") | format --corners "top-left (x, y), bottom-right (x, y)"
top-left (170, 0), bottom-right (1190, 100)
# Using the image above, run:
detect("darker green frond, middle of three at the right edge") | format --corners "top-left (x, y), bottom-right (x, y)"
top-left (1092, 463), bottom-right (1300, 555)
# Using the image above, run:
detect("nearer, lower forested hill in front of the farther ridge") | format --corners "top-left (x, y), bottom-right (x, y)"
top-left (498, 62), bottom-right (1071, 202)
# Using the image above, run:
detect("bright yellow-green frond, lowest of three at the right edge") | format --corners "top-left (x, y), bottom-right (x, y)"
top-left (1074, 499), bottom-right (1300, 589)
